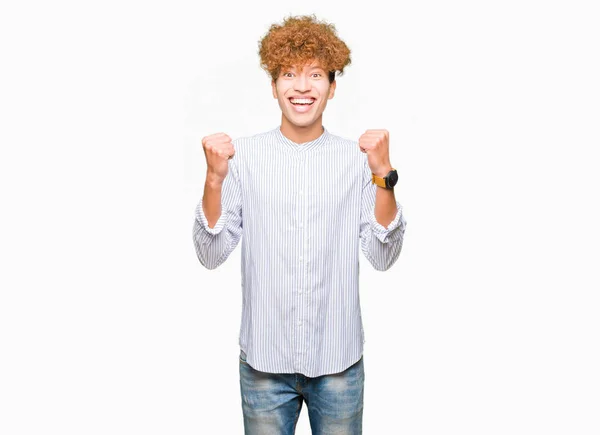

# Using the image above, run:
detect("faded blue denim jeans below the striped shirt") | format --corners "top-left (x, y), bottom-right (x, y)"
top-left (240, 351), bottom-right (365, 435)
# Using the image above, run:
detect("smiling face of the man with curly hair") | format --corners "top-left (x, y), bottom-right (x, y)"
top-left (271, 61), bottom-right (336, 127)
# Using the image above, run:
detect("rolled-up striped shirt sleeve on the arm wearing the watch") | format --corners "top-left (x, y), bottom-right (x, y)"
top-left (360, 158), bottom-right (406, 271)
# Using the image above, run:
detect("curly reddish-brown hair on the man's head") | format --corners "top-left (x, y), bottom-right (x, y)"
top-left (258, 14), bottom-right (351, 83)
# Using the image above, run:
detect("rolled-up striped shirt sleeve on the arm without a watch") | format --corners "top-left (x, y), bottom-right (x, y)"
top-left (193, 157), bottom-right (242, 269)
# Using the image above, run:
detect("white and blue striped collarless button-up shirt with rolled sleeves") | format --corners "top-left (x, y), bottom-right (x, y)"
top-left (193, 127), bottom-right (406, 377)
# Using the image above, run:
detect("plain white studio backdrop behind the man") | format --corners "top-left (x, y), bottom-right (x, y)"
top-left (0, 0), bottom-right (600, 435)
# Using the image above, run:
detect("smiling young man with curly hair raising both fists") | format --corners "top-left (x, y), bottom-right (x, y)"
top-left (193, 16), bottom-right (406, 435)
